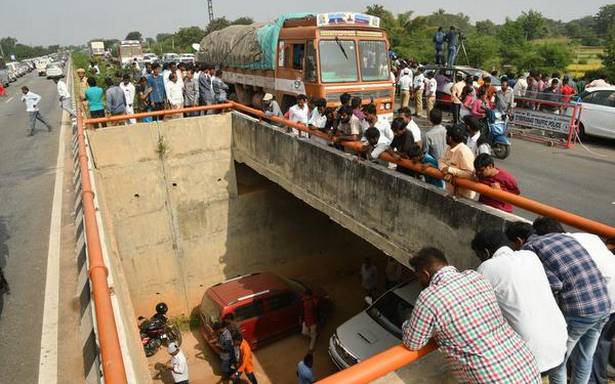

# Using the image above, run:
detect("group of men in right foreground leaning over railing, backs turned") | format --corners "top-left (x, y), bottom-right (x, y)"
top-left (403, 217), bottom-right (615, 384)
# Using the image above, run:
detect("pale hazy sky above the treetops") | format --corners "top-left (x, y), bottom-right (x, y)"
top-left (0, 0), bottom-right (613, 45)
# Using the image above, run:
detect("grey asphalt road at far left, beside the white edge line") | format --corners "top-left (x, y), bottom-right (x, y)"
top-left (0, 72), bottom-right (67, 383)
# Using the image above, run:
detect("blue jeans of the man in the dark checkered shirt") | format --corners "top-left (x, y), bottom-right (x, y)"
top-left (549, 314), bottom-right (609, 384)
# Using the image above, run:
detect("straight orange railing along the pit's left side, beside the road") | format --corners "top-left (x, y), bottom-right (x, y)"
top-left (77, 103), bottom-right (127, 384)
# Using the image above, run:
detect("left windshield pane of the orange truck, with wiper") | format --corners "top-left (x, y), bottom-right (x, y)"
top-left (319, 40), bottom-right (359, 83)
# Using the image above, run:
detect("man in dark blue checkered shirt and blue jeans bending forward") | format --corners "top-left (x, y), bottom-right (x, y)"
top-left (506, 222), bottom-right (611, 384)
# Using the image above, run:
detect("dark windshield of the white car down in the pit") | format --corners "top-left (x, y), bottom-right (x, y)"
top-left (367, 291), bottom-right (412, 339)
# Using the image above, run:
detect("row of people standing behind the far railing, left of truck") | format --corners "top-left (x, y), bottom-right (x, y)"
top-left (77, 59), bottom-right (229, 126)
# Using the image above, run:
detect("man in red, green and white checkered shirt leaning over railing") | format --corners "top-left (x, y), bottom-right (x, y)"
top-left (403, 248), bottom-right (541, 384)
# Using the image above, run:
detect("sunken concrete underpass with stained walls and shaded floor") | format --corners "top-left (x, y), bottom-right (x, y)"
top-left (88, 113), bottom-right (515, 383)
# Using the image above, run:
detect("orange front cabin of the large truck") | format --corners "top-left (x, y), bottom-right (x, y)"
top-left (275, 14), bottom-right (394, 117)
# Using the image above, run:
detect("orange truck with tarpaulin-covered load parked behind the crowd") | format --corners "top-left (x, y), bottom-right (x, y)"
top-left (197, 12), bottom-right (395, 120)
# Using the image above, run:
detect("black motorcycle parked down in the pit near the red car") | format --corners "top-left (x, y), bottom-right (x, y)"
top-left (139, 310), bottom-right (182, 357)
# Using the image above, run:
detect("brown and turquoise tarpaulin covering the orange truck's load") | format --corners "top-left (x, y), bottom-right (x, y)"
top-left (197, 13), bottom-right (315, 69)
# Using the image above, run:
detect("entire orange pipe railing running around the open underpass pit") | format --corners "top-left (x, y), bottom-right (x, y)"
top-left (77, 101), bottom-right (615, 384)
